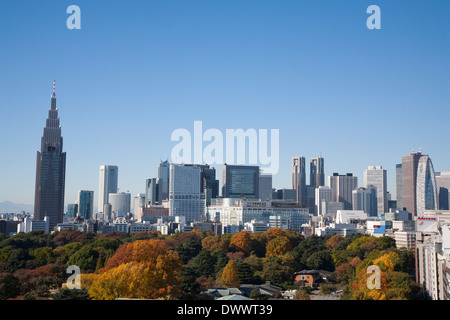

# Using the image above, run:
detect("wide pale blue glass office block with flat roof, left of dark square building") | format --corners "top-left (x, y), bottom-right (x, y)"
top-left (169, 164), bottom-right (206, 223)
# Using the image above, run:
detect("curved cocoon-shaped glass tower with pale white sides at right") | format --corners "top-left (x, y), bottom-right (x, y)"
top-left (416, 155), bottom-right (439, 216)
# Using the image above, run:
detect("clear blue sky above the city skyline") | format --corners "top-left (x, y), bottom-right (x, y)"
top-left (0, 0), bottom-right (450, 209)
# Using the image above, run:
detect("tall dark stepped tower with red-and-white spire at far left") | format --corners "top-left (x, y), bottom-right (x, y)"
top-left (34, 81), bottom-right (66, 230)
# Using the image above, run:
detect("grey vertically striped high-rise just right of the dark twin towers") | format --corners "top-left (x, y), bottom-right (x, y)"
top-left (328, 173), bottom-right (358, 210)
